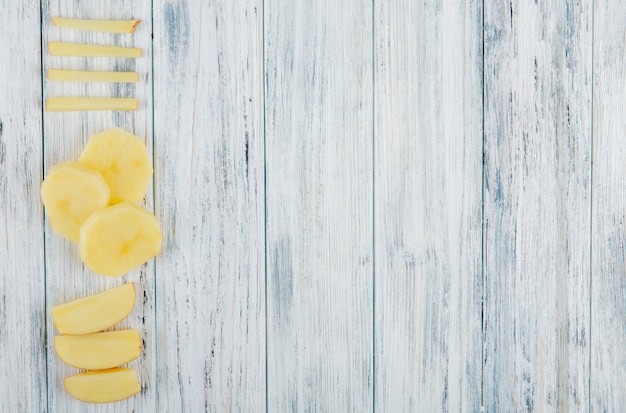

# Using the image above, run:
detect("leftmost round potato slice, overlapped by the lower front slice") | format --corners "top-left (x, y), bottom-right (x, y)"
top-left (41, 162), bottom-right (110, 242)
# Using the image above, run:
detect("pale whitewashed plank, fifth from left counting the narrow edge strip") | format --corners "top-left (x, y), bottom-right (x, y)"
top-left (374, 1), bottom-right (482, 412)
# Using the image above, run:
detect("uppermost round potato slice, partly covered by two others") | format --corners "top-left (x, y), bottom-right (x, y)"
top-left (78, 128), bottom-right (152, 204)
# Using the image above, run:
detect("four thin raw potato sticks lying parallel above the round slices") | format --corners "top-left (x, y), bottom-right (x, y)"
top-left (46, 17), bottom-right (142, 112)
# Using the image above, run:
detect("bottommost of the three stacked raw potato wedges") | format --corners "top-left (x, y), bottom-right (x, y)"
top-left (63, 368), bottom-right (141, 403)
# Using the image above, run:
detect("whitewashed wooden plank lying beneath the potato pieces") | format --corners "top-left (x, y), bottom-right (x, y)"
top-left (42, 0), bottom-right (157, 412)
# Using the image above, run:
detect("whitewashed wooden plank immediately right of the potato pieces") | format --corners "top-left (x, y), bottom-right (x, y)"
top-left (154, 0), bottom-right (265, 412)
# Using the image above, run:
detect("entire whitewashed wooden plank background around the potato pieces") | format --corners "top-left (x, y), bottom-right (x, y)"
top-left (0, 0), bottom-right (626, 412)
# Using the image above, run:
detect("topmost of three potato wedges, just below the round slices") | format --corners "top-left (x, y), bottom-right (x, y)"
top-left (51, 282), bottom-right (135, 335)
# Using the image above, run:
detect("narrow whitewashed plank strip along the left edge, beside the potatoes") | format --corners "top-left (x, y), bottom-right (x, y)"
top-left (0, 2), bottom-right (47, 412)
